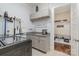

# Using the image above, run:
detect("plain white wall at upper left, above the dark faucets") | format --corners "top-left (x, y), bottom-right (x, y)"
top-left (0, 3), bottom-right (32, 32)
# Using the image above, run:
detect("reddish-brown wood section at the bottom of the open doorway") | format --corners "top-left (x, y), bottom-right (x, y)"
top-left (54, 42), bottom-right (71, 55)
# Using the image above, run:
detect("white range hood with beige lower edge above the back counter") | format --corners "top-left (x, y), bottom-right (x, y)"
top-left (31, 9), bottom-right (49, 21)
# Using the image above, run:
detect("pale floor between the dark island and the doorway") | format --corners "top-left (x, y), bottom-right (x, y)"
top-left (32, 49), bottom-right (69, 56)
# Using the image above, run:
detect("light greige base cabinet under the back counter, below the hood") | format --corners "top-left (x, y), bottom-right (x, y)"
top-left (31, 36), bottom-right (50, 52)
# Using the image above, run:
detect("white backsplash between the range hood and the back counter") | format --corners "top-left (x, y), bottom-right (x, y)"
top-left (33, 18), bottom-right (51, 33)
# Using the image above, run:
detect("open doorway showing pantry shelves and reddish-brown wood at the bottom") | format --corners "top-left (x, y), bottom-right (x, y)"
top-left (54, 4), bottom-right (71, 55)
